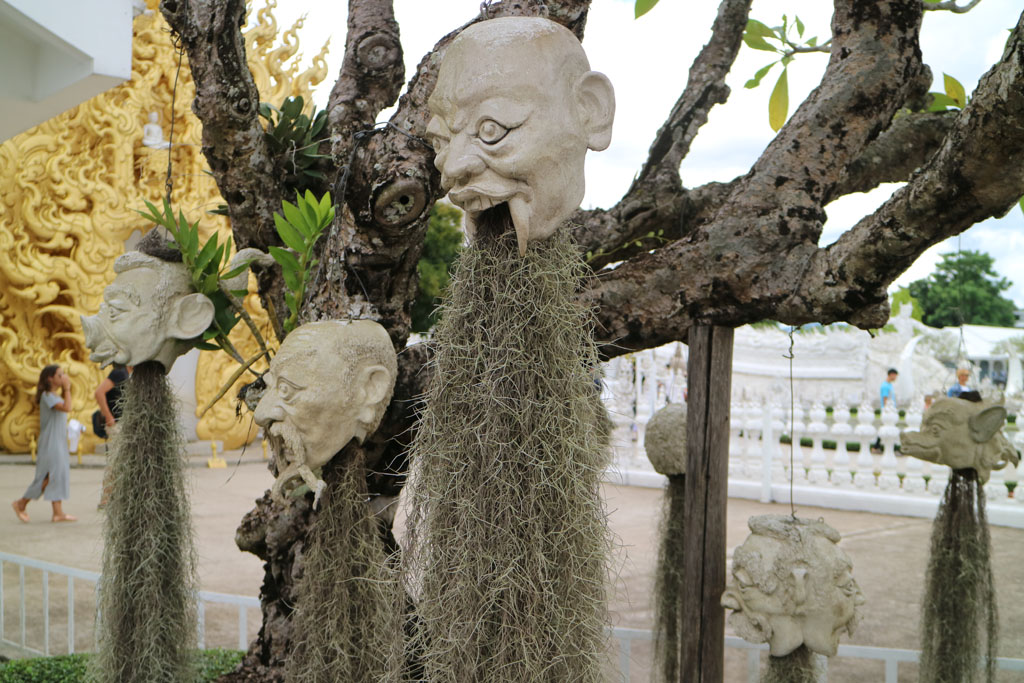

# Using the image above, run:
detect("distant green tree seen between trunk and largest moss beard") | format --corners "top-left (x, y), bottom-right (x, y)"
top-left (413, 202), bottom-right (463, 333)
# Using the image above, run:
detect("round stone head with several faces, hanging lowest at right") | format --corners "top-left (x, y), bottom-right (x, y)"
top-left (722, 515), bottom-right (864, 656)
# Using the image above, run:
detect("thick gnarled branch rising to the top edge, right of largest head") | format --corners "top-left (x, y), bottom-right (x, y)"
top-left (584, 0), bottom-right (923, 355)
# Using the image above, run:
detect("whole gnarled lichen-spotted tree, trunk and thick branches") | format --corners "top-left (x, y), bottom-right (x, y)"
top-left (161, 0), bottom-right (1024, 680)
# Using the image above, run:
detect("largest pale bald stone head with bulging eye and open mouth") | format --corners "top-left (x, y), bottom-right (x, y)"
top-left (427, 17), bottom-right (615, 254)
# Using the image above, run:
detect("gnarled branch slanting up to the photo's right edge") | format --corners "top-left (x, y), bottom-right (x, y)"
top-left (782, 7), bottom-right (1024, 327)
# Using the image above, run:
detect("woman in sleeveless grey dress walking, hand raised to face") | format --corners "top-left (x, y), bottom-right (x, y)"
top-left (10, 366), bottom-right (77, 522)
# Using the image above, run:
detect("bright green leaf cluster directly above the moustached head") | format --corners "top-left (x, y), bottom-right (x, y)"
top-left (270, 189), bottom-right (334, 332)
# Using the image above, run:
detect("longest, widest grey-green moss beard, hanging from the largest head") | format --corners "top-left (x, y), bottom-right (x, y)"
top-left (403, 205), bottom-right (610, 683)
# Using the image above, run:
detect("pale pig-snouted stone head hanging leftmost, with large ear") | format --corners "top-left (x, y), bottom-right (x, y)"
top-left (82, 252), bottom-right (214, 371)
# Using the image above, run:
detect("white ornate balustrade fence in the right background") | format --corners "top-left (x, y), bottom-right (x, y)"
top-left (603, 352), bottom-right (1024, 528)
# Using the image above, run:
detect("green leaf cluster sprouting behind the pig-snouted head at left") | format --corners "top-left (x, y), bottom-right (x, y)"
top-left (139, 199), bottom-right (249, 351)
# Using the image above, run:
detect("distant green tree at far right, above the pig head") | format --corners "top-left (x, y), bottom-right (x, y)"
top-left (907, 251), bottom-right (1017, 328)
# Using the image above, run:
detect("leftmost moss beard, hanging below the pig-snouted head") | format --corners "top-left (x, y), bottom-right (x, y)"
top-left (91, 361), bottom-right (199, 683)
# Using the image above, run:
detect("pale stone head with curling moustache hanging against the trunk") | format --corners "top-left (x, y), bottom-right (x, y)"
top-left (255, 321), bottom-right (397, 502)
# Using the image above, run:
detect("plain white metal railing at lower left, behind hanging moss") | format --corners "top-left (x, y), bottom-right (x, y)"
top-left (0, 552), bottom-right (260, 655)
